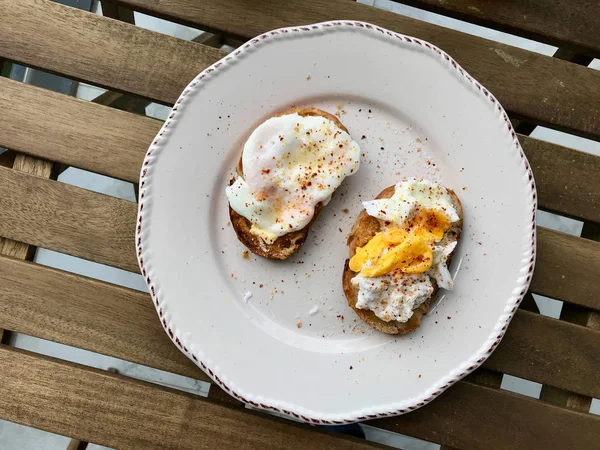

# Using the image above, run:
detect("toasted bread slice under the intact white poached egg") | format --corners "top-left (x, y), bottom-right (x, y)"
top-left (229, 108), bottom-right (348, 260)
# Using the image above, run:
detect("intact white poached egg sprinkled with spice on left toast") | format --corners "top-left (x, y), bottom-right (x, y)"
top-left (225, 113), bottom-right (360, 244)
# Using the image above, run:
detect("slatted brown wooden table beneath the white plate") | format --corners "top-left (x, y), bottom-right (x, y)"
top-left (0, 0), bottom-right (600, 449)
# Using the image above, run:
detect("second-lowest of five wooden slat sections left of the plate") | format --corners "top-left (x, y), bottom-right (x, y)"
top-left (0, 257), bottom-right (204, 381)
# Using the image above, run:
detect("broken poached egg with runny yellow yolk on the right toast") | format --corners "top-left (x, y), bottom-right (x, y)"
top-left (350, 178), bottom-right (460, 322)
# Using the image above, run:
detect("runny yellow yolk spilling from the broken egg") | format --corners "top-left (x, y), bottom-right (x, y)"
top-left (350, 210), bottom-right (452, 278)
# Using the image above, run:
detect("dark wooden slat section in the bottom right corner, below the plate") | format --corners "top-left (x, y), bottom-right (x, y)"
top-left (371, 381), bottom-right (600, 450)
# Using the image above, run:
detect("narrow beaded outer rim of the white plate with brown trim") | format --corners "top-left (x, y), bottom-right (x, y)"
top-left (135, 20), bottom-right (537, 425)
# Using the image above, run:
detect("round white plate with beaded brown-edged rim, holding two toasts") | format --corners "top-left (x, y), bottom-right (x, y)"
top-left (136, 22), bottom-right (536, 423)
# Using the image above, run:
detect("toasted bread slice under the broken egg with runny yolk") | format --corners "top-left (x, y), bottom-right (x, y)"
top-left (342, 186), bottom-right (463, 334)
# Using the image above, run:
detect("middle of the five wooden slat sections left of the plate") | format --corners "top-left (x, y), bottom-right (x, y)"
top-left (0, 167), bottom-right (139, 272)
